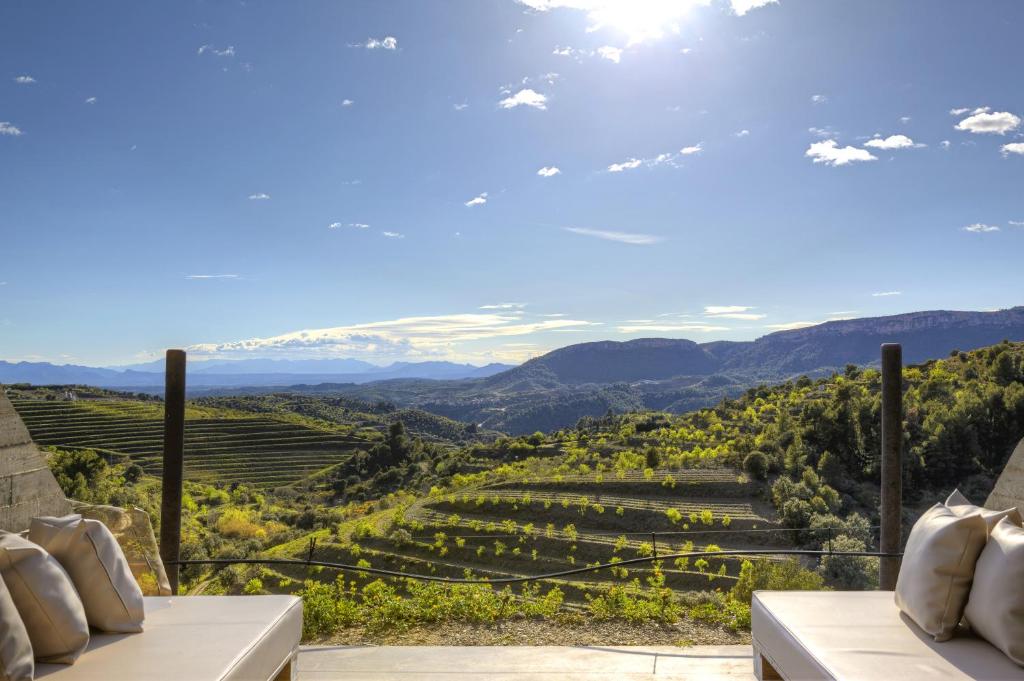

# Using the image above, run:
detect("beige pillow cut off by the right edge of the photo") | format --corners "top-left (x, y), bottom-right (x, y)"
top-left (964, 518), bottom-right (1024, 666)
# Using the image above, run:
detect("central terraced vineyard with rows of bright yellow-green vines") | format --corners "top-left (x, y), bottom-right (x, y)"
top-left (272, 468), bottom-right (792, 606)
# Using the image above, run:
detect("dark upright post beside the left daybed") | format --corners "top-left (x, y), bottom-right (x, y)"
top-left (160, 350), bottom-right (185, 595)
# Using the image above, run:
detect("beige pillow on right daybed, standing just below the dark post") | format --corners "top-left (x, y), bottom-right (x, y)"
top-left (895, 504), bottom-right (988, 641)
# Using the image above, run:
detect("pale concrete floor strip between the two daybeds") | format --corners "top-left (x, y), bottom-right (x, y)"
top-left (298, 645), bottom-right (754, 681)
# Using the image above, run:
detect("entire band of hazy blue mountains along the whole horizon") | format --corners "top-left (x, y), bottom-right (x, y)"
top-left (8, 306), bottom-right (1024, 433)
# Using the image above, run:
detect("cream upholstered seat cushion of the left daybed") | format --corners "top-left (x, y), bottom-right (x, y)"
top-left (36, 596), bottom-right (302, 681)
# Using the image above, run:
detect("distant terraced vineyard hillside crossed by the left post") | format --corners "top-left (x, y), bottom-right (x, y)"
top-left (12, 399), bottom-right (368, 488)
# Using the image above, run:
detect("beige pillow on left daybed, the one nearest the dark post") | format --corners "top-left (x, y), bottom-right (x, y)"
top-left (29, 514), bottom-right (145, 634)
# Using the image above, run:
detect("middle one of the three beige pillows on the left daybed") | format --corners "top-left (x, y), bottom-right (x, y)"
top-left (0, 530), bottom-right (89, 665)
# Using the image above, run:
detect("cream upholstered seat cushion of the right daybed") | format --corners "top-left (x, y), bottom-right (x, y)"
top-left (751, 591), bottom-right (1024, 681)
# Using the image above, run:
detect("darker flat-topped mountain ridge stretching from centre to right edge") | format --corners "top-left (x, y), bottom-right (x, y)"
top-left (291, 307), bottom-right (1024, 433)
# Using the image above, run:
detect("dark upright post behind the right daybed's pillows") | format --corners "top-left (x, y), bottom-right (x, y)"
top-left (879, 343), bottom-right (903, 591)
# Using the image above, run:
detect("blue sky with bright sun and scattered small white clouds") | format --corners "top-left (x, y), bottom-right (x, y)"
top-left (0, 0), bottom-right (1024, 366)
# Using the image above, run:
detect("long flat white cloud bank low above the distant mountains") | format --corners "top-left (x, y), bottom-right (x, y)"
top-left (187, 312), bottom-right (596, 358)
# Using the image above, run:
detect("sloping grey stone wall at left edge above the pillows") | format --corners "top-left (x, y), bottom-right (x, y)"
top-left (0, 388), bottom-right (71, 531)
